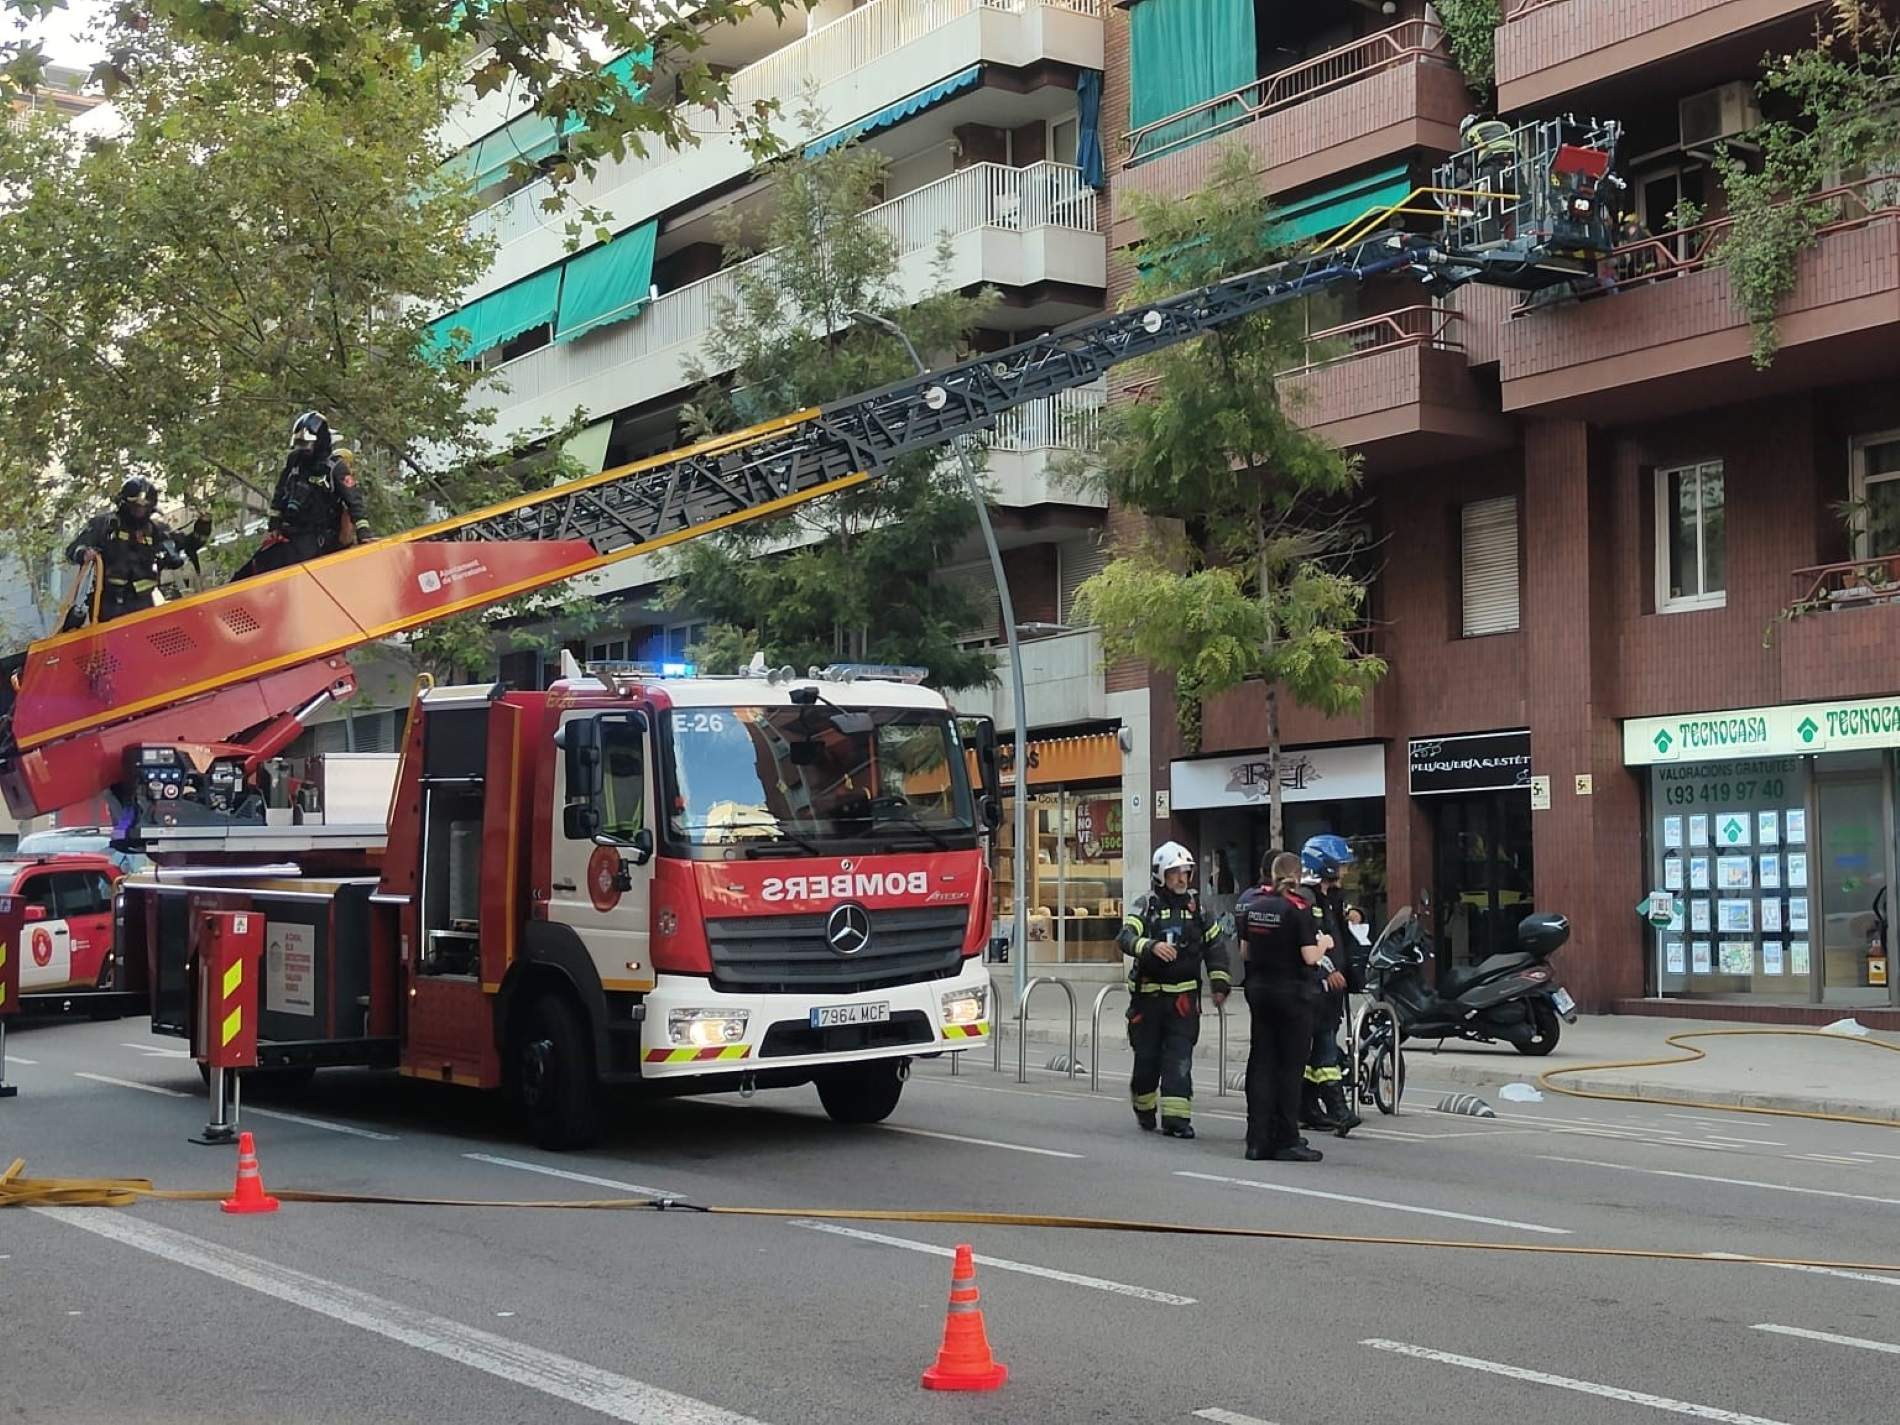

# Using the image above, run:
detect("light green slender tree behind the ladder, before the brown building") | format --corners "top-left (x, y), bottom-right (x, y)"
top-left (1077, 148), bottom-right (1385, 846)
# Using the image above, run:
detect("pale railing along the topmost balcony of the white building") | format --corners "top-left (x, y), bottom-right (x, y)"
top-left (469, 0), bottom-right (1104, 245)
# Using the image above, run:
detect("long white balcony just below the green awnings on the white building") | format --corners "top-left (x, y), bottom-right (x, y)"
top-left (473, 163), bottom-right (1108, 439)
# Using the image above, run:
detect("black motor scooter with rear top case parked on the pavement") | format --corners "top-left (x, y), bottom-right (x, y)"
top-left (1366, 906), bottom-right (1577, 1055)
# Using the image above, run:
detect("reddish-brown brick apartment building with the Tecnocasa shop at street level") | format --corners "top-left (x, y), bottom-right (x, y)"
top-left (1102, 0), bottom-right (1900, 1022)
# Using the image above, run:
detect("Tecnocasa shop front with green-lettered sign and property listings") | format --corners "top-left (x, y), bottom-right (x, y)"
top-left (1623, 695), bottom-right (1900, 1007)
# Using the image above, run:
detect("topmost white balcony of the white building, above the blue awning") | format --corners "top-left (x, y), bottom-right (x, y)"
top-left (469, 0), bottom-right (1104, 296)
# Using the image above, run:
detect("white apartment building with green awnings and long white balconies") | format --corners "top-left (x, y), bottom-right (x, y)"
top-left (435, 0), bottom-right (1151, 975)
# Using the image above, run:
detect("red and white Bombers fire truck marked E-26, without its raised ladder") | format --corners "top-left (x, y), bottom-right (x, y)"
top-left (122, 667), bottom-right (996, 1148)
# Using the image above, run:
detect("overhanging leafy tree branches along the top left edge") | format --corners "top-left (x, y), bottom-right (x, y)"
top-left (0, 0), bottom-right (785, 182)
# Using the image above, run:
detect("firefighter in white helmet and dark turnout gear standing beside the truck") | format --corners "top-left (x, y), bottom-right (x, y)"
top-left (1119, 842), bottom-right (1233, 1138)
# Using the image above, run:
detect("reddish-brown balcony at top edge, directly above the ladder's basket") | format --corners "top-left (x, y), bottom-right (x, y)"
top-left (1497, 0), bottom-right (1820, 114)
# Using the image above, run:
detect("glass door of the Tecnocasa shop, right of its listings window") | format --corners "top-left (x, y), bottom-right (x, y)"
top-left (1815, 770), bottom-right (1892, 1005)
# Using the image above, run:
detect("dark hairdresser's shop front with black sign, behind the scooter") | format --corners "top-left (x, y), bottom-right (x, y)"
top-left (1406, 728), bottom-right (1535, 975)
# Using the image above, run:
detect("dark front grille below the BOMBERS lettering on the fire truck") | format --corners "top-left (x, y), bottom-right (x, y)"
top-left (707, 906), bottom-right (969, 994)
